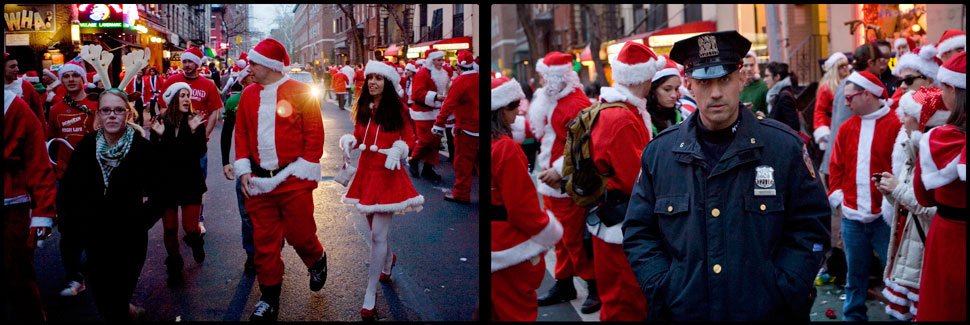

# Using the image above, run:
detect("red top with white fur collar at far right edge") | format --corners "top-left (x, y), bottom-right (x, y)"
top-left (912, 124), bottom-right (967, 209)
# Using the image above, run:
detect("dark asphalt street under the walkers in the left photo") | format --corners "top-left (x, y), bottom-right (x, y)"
top-left (34, 95), bottom-right (480, 321)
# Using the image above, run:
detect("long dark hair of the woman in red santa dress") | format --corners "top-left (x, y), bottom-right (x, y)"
top-left (353, 78), bottom-right (407, 132)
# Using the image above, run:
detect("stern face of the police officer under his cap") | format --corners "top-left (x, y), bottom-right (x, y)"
top-left (687, 70), bottom-right (743, 130)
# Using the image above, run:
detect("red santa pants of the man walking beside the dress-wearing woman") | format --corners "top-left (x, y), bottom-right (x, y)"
top-left (246, 190), bottom-right (323, 286)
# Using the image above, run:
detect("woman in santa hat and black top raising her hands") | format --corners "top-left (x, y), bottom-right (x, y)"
top-left (152, 82), bottom-right (207, 287)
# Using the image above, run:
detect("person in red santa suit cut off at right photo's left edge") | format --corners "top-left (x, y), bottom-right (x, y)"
top-left (488, 77), bottom-right (563, 322)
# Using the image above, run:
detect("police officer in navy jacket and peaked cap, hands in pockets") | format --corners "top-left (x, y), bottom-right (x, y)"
top-left (623, 31), bottom-right (830, 321)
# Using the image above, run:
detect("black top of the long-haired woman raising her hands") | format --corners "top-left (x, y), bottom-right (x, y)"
top-left (150, 117), bottom-right (208, 207)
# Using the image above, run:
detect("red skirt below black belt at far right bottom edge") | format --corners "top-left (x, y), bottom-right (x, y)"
top-left (916, 215), bottom-right (967, 322)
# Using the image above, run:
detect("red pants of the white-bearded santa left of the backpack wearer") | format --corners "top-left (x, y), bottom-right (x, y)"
top-left (542, 196), bottom-right (596, 280)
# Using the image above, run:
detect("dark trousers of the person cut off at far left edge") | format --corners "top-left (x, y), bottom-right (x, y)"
top-left (0, 204), bottom-right (46, 322)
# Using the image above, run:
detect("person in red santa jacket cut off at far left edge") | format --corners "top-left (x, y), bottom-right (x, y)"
top-left (0, 90), bottom-right (56, 324)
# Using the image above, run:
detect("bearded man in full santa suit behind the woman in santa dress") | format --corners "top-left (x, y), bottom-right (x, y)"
top-left (408, 49), bottom-right (449, 181)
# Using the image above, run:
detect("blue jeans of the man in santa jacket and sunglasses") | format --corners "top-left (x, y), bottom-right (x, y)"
top-left (842, 218), bottom-right (890, 321)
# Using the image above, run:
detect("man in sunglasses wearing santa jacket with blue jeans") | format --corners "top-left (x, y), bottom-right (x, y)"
top-left (829, 71), bottom-right (902, 321)
